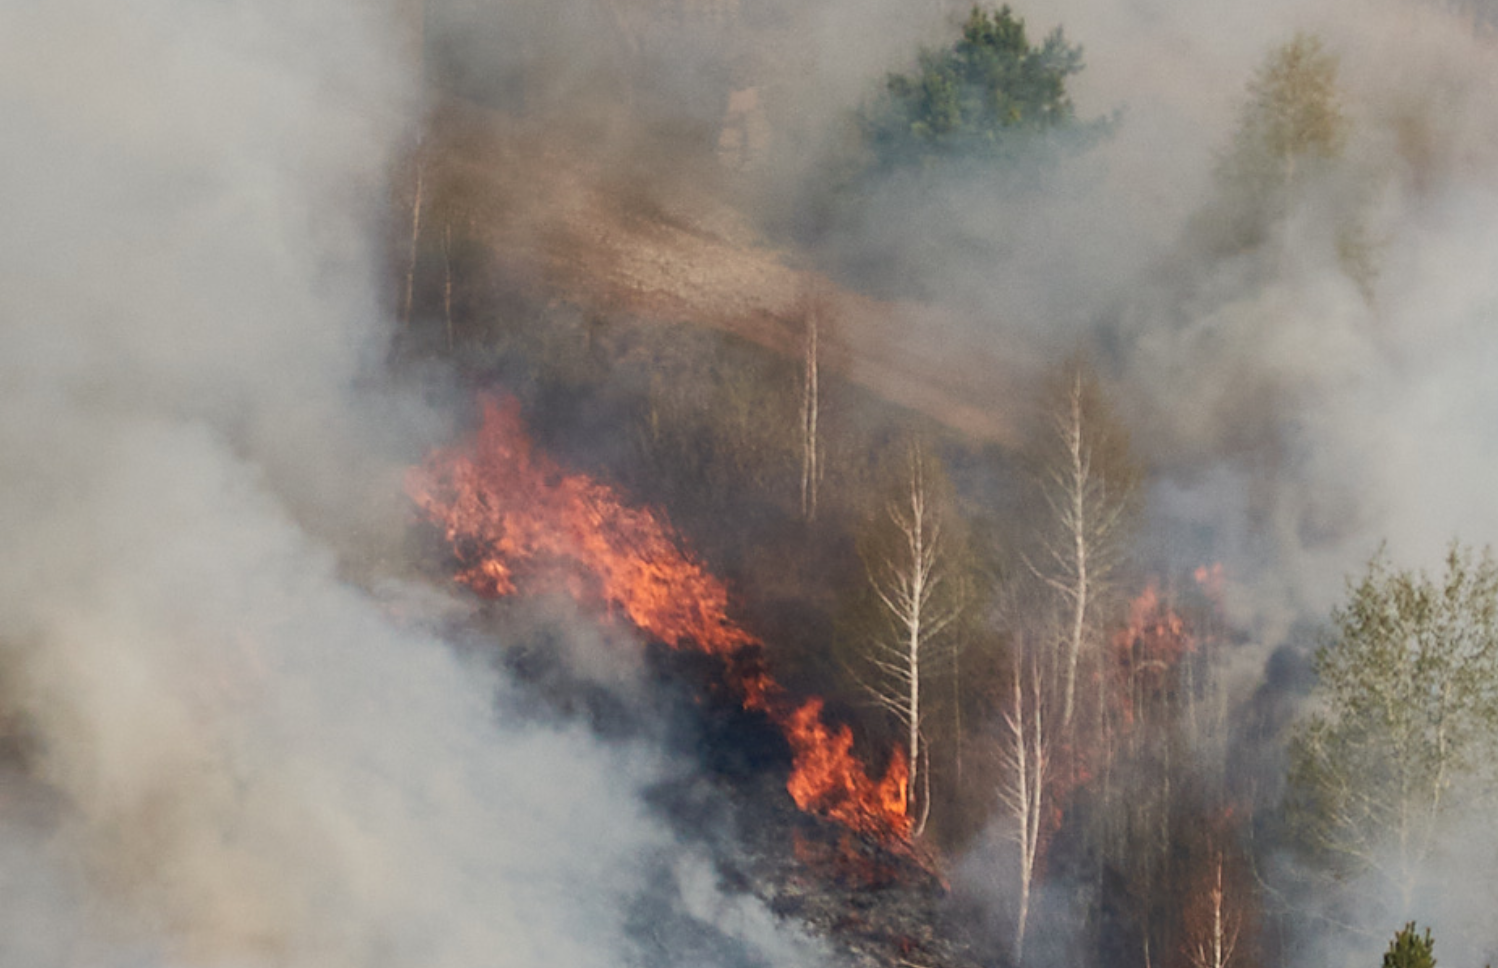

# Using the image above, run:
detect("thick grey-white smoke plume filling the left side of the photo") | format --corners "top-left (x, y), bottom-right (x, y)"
top-left (0, 0), bottom-right (815, 968)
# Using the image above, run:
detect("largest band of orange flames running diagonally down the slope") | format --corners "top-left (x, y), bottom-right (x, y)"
top-left (406, 397), bottom-right (911, 842)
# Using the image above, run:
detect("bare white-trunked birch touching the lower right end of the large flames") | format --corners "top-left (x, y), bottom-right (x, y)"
top-left (863, 445), bottom-right (966, 833)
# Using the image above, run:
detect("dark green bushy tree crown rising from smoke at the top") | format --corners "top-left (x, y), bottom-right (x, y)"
top-left (864, 6), bottom-right (1082, 166)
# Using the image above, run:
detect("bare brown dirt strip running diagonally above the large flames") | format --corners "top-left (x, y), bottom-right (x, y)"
top-left (424, 100), bottom-right (1017, 444)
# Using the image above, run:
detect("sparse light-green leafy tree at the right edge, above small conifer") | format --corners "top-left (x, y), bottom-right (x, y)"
top-left (1290, 545), bottom-right (1498, 901)
